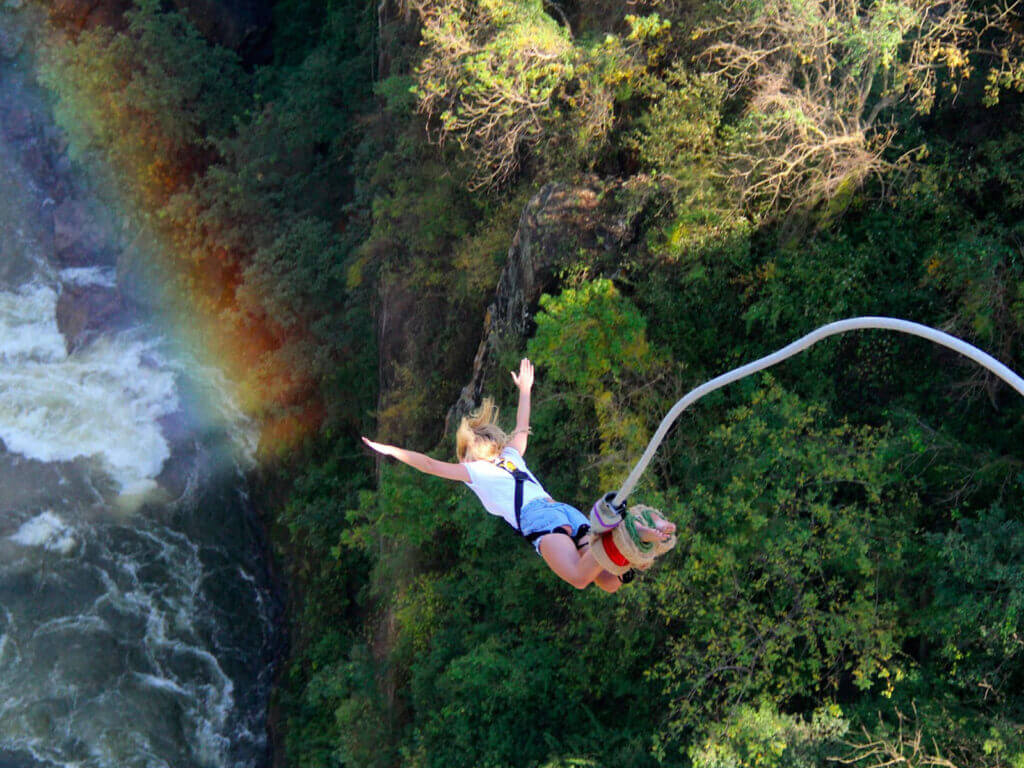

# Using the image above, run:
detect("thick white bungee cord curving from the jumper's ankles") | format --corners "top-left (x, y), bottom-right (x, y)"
top-left (598, 317), bottom-right (1024, 509)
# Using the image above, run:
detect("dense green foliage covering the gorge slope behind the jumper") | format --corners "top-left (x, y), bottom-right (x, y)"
top-left (32, 0), bottom-right (1024, 768)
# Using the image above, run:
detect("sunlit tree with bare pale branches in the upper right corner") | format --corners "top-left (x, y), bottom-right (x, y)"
top-left (700, 0), bottom-right (1024, 214)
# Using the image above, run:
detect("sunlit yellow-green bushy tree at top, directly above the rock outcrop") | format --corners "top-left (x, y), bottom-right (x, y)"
top-left (415, 0), bottom-right (669, 188)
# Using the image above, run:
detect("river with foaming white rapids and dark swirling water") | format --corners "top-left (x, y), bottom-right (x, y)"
top-left (0, 7), bottom-right (276, 768)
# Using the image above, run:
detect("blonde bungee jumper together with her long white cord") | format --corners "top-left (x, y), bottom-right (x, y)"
top-left (362, 316), bottom-right (1024, 592)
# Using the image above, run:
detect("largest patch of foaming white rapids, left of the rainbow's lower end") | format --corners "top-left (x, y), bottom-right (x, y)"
top-left (0, 285), bottom-right (178, 494)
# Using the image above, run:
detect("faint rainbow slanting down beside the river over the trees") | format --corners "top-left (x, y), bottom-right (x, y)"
top-left (24, 4), bottom-right (325, 458)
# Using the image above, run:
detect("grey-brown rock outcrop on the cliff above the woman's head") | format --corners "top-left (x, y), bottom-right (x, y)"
top-left (445, 179), bottom-right (643, 434)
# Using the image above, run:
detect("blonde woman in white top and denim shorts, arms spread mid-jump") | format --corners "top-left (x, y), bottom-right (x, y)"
top-left (362, 357), bottom-right (676, 592)
